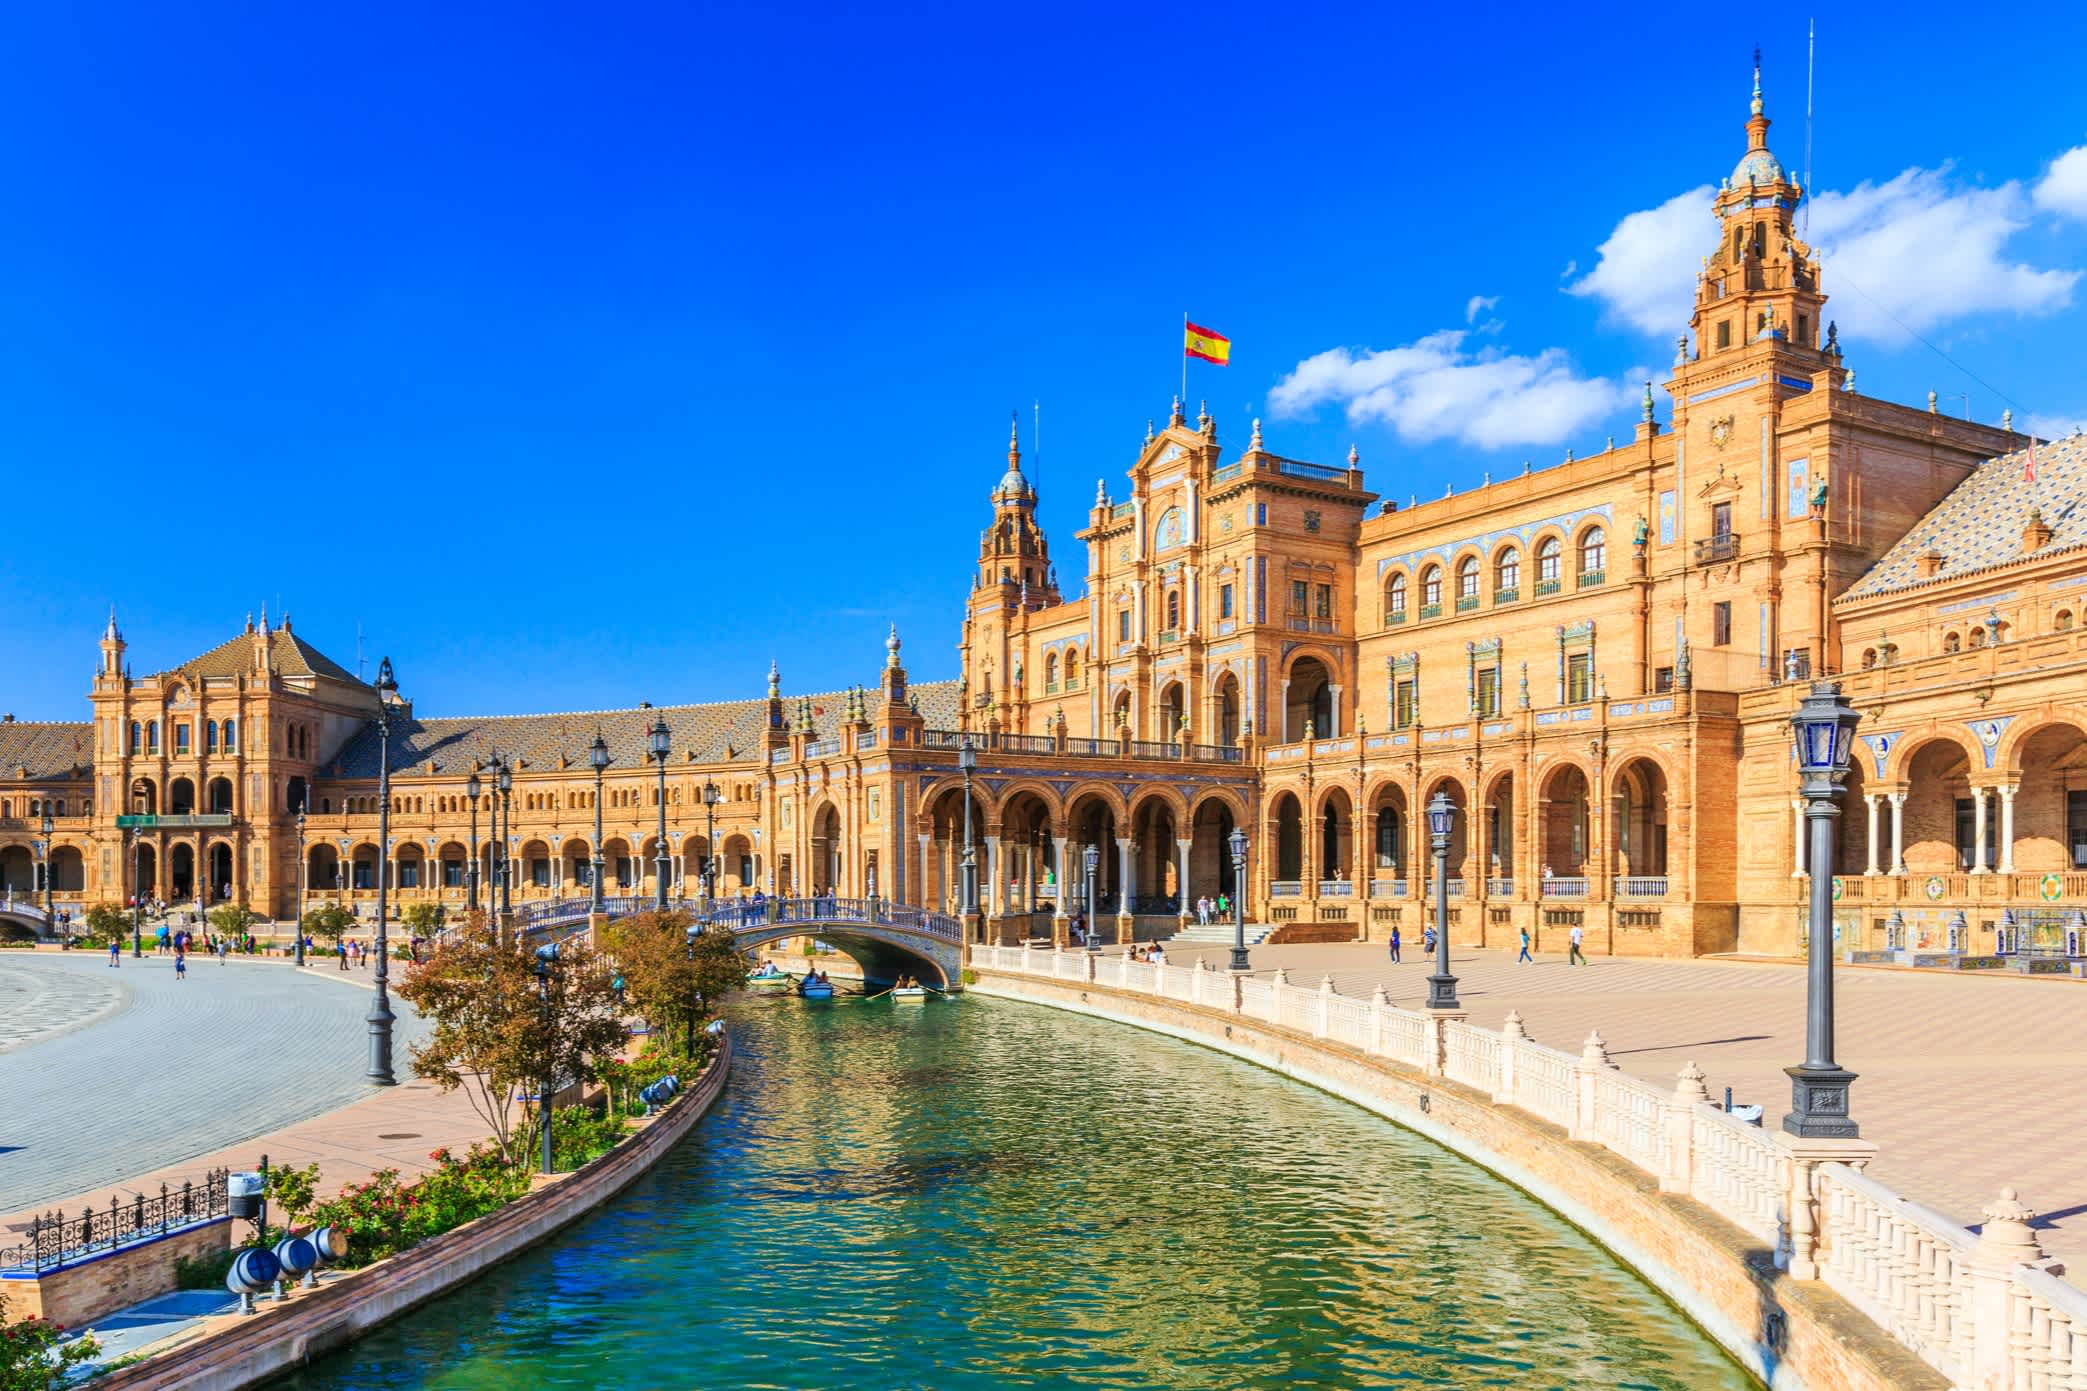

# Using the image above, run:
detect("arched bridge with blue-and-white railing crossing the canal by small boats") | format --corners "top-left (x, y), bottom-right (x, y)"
top-left (515, 895), bottom-right (964, 991)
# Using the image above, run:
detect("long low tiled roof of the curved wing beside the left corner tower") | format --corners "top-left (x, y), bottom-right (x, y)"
top-left (323, 680), bottom-right (958, 778)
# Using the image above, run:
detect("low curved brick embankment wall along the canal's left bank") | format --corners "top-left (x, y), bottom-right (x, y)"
top-left (94, 1034), bottom-right (733, 1391)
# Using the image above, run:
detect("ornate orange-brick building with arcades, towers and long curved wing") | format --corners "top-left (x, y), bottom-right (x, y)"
top-left (0, 70), bottom-right (2087, 955)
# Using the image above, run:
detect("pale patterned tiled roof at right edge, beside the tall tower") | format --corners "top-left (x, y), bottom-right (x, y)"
top-left (1843, 434), bottom-right (2087, 599)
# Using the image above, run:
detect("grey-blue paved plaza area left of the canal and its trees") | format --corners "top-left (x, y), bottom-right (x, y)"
top-left (0, 951), bottom-right (426, 1214)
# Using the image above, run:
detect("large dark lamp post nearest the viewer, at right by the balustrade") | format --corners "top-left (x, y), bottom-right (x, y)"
top-left (1782, 682), bottom-right (1862, 1139)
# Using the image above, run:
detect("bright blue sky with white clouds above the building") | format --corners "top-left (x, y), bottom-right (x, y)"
top-left (0, 4), bottom-right (2087, 719)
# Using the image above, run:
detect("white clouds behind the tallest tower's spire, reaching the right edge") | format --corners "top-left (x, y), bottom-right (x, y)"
top-left (1565, 158), bottom-right (2087, 340)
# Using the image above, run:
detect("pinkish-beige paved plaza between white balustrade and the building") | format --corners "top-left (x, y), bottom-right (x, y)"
top-left (1167, 943), bottom-right (2087, 1278)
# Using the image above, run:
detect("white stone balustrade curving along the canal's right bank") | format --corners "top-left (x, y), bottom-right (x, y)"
top-left (970, 942), bottom-right (2087, 1391)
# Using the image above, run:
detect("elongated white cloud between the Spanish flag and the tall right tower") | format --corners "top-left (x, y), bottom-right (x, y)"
top-left (1269, 330), bottom-right (1634, 448)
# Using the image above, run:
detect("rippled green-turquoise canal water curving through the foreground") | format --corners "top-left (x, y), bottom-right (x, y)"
top-left (278, 997), bottom-right (1753, 1391)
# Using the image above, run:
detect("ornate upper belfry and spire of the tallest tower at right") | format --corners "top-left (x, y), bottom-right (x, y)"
top-left (1688, 52), bottom-right (1826, 371)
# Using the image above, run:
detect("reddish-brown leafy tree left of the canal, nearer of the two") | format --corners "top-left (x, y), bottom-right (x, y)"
top-left (399, 913), bottom-right (630, 1164)
